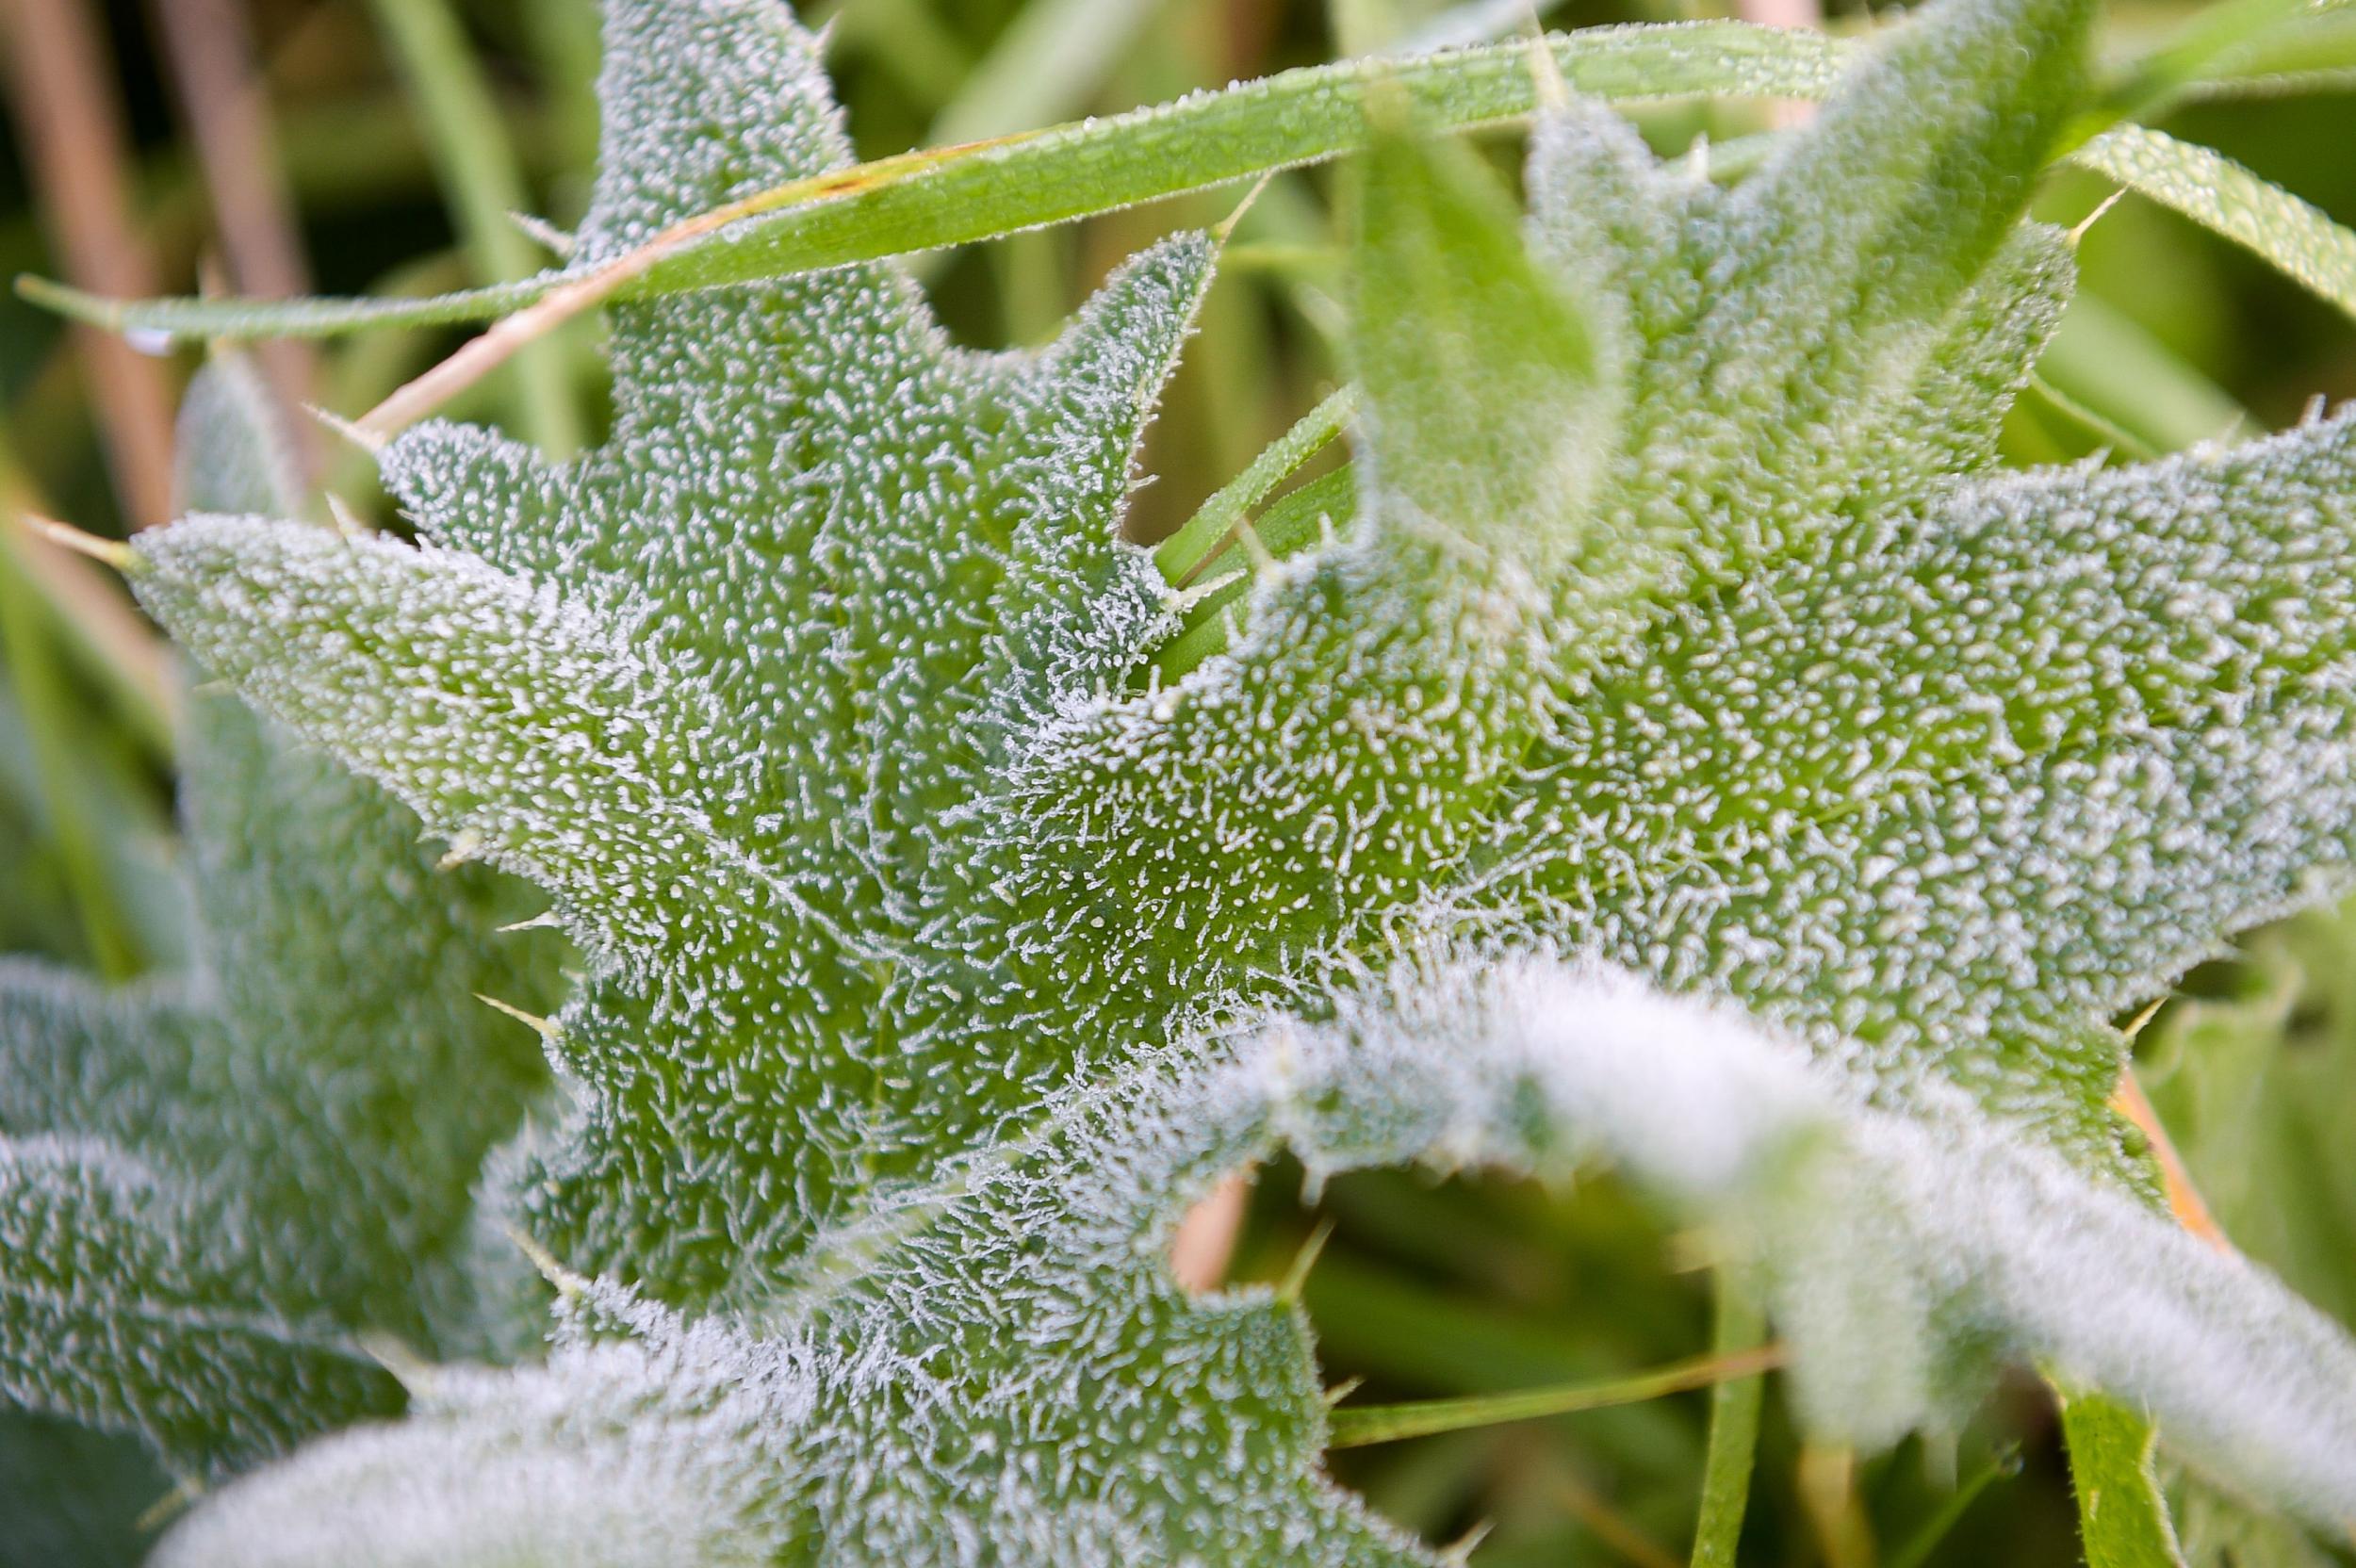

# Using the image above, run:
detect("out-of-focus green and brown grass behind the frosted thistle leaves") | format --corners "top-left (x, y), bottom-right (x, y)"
top-left (0, 0), bottom-right (2356, 1568)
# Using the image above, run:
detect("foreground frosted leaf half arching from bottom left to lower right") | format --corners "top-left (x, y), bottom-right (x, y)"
top-left (163, 958), bottom-right (2356, 1566)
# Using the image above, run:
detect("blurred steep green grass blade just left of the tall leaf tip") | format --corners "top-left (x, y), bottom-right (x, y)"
top-left (375, 0), bottom-right (582, 457)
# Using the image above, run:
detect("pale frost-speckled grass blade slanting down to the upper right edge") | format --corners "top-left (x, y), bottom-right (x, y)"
top-left (2076, 124), bottom-right (2356, 318)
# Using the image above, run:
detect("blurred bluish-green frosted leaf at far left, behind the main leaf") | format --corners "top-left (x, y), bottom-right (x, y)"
top-left (0, 363), bottom-right (547, 1474)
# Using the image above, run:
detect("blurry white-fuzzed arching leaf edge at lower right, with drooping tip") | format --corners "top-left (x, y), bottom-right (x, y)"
top-left (1249, 960), bottom-right (2356, 1524)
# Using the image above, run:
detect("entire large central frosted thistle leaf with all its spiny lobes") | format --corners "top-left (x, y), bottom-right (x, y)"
top-left (91, 0), bottom-right (2356, 1563)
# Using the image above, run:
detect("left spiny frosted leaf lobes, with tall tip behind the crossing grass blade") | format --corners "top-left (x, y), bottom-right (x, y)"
top-left (144, 0), bottom-right (1211, 1299)
